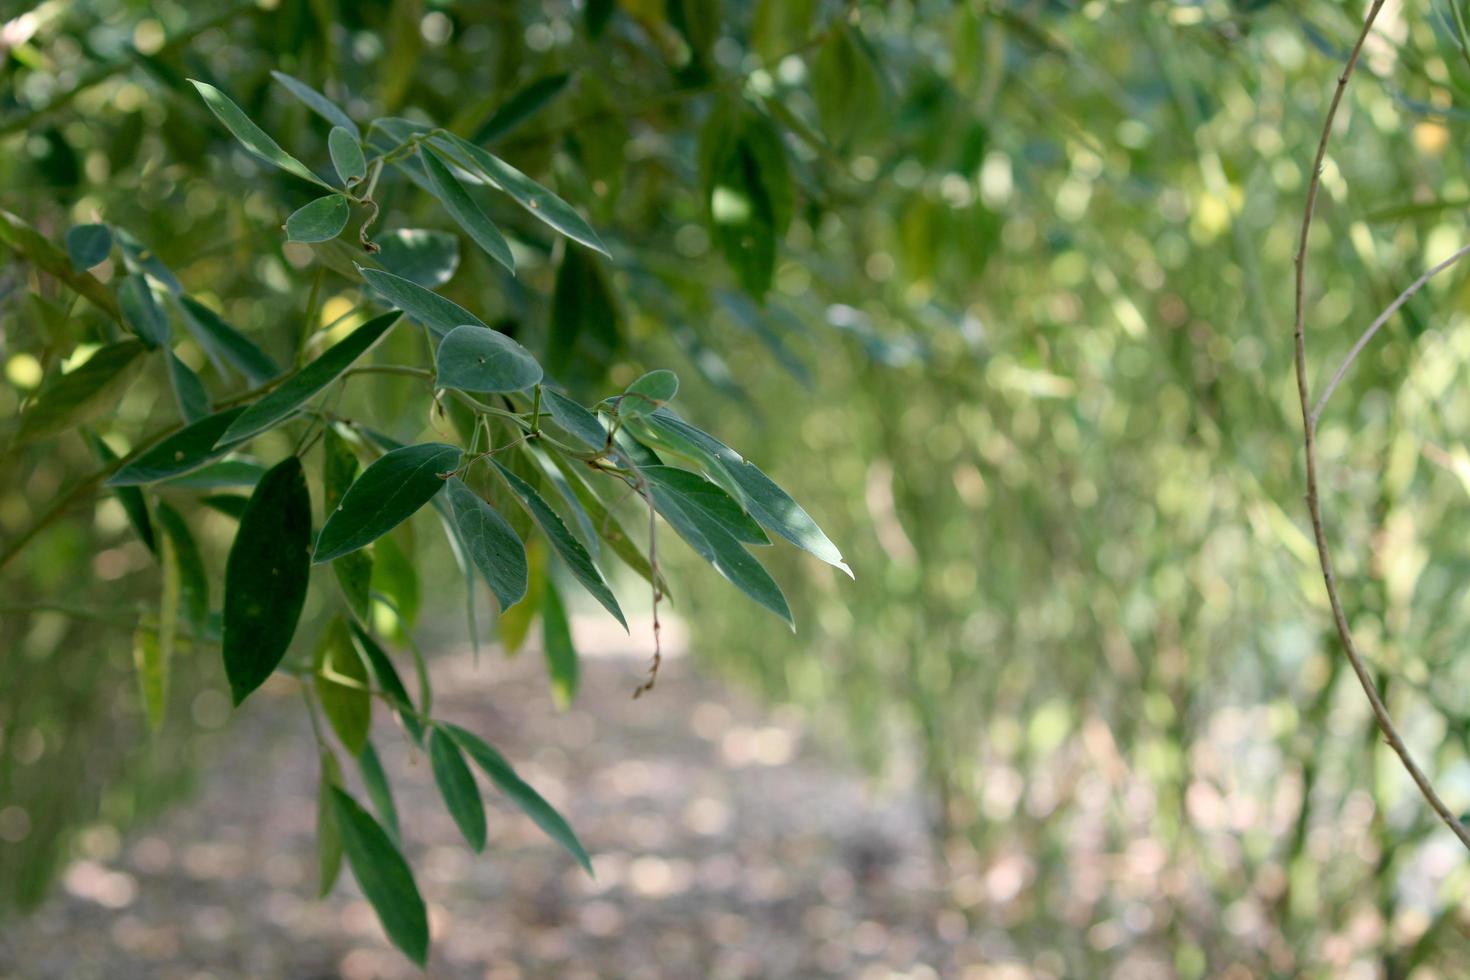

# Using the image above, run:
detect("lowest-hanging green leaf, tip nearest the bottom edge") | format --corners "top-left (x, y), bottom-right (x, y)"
top-left (329, 786), bottom-right (429, 967)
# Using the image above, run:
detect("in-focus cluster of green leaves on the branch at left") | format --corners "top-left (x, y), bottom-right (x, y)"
top-left (0, 72), bottom-right (847, 964)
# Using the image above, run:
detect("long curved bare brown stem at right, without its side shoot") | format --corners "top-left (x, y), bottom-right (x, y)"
top-left (1292, 0), bottom-right (1470, 849)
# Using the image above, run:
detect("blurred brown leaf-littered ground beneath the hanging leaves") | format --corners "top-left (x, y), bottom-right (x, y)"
top-left (0, 631), bottom-right (979, 980)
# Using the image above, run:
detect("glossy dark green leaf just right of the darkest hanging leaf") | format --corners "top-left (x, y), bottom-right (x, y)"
top-left (312, 442), bottom-right (460, 564)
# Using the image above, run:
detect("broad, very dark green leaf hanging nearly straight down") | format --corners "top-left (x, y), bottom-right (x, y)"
top-left (223, 455), bottom-right (312, 705)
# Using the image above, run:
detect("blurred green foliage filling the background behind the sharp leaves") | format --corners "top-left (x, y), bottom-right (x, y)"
top-left (0, 0), bottom-right (1470, 977)
